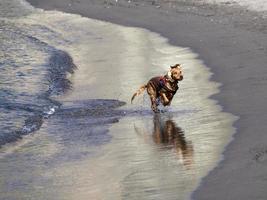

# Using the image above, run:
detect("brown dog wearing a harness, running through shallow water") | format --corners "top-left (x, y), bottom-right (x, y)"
top-left (131, 64), bottom-right (183, 112)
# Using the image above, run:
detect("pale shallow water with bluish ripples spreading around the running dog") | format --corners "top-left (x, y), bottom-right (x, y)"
top-left (0, 1), bottom-right (239, 200)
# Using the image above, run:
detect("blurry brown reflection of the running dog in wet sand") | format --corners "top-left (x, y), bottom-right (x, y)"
top-left (135, 114), bottom-right (194, 169)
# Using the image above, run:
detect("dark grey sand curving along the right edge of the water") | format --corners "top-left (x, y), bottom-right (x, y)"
top-left (25, 0), bottom-right (267, 200)
